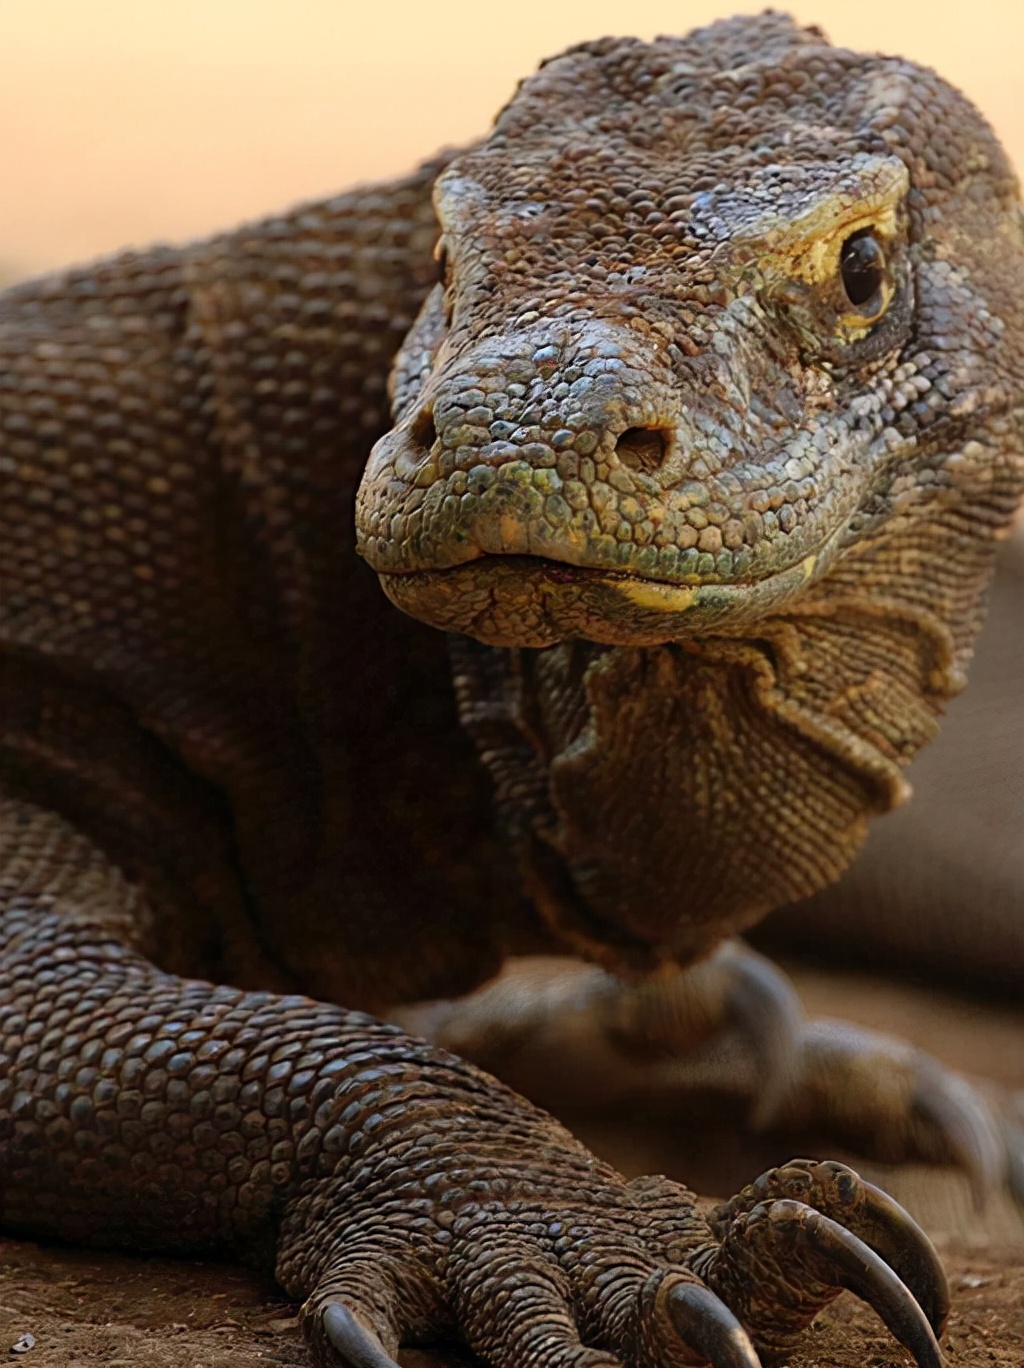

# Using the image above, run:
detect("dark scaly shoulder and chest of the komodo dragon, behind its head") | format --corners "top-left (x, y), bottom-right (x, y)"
top-left (5, 157), bottom-right (522, 1010)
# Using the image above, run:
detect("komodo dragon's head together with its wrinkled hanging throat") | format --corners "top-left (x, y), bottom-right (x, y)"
top-left (357, 15), bottom-right (1024, 974)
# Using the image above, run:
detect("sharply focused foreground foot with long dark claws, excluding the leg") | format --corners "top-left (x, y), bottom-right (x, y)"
top-left (287, 1160), bottom-right (949, 1368)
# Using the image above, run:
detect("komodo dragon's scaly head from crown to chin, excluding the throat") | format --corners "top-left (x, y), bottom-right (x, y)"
top-left (358, 15), bottom-right (1021, 646)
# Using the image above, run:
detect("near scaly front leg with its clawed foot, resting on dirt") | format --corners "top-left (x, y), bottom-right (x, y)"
top-left (0, 802), bottom-right (945, 1368)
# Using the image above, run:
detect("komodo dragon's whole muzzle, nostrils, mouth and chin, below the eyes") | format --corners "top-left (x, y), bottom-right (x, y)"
top-left (357, 304), bottom-right (857, 646)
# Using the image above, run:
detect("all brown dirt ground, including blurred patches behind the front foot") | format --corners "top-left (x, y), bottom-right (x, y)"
top-left (0, 971), bottom-right (1024, 1368)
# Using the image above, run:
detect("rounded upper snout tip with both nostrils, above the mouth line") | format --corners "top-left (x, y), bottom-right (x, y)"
top-left (358, 319), bottom-right (691, 577)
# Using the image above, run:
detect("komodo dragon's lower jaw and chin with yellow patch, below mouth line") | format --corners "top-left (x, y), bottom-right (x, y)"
top-left (380, 555), bottom-right (822, 648)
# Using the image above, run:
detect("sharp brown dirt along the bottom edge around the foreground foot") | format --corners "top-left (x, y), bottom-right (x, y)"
top-left (0, 1203), bottom-right (1024, 1368)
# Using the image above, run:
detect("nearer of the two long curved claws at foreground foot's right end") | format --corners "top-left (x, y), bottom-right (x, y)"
top-left (767, 1198), bottom-right (942, 1368)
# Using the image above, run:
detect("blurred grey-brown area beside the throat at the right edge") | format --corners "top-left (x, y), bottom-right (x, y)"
top-left (759, 524), bottom-right (1024, 1000)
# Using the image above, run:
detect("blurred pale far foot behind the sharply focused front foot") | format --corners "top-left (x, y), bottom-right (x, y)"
top-left (401, 941), bottom-right (1024, 1205)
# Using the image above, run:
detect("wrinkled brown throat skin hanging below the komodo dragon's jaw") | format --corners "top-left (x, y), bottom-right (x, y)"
top-left (450, 514), bottom-right (990, 974)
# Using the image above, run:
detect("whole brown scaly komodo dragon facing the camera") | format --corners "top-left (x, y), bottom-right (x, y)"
top-left (0, 15), bottom-right (1024, 1368)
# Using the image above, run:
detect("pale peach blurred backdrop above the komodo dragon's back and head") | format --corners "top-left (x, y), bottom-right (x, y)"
top-left (0, 0), bottom-right (1024, 282)
